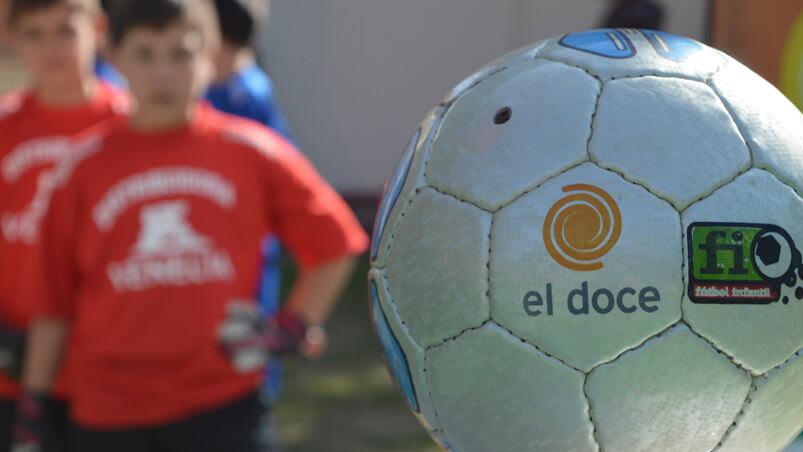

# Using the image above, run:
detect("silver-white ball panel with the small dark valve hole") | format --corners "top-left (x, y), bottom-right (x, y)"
top-left (426, 60), bottom-right (599, 210)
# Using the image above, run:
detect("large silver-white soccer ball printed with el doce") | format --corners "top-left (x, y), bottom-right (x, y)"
top-left (369, 29), bottom-right (803, 452)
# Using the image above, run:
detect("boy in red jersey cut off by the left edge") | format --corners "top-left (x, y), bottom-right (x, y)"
top-left (0, 0), bottom-right (122, 452)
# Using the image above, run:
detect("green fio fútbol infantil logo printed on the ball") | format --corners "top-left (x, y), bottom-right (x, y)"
top-left (686, 222), bottom-right (803, 304)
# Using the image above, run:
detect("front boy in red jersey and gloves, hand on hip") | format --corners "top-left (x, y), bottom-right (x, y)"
top-left (18, 0), bottom-right (367, 452)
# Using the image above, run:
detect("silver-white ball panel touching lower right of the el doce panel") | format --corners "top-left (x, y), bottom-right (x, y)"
top-left (586, 325), bottom-right (752, 452)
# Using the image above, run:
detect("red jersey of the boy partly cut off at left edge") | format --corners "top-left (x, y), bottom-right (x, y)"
top-left (0, 84), bottom-right (127, 398)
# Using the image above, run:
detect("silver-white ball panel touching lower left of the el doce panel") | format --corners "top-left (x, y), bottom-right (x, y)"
top-left (427, 324), bottom-right (596, 452)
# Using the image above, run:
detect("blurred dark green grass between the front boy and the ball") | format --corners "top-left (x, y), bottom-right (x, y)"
top-left (277, 260), bottom-right (439, 452)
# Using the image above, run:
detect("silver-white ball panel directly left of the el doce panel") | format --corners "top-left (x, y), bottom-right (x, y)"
top-left (386, 188), bottom-right (491, 348)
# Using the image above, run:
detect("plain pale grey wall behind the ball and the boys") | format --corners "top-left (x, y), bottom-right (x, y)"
top-left (261, 0), bottom-right (705, 194)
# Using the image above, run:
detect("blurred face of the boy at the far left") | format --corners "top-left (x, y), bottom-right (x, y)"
top-left (11, 3), bottom-right (99, 90)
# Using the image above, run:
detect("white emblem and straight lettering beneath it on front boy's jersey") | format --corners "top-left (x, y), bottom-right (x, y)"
top-left (108, 201), bottom-right (235, 293)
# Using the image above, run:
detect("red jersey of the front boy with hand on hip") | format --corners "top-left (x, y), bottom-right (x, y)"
top-left (32, 106), bottom-right (367, 429)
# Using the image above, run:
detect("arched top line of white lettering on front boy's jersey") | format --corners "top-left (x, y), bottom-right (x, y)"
top-left (92, 166), bottom-right (237, 231)
